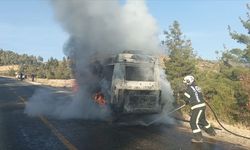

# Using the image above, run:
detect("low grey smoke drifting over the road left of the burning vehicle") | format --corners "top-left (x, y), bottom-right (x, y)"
top-left (24, 88), bottom-right (110, 119)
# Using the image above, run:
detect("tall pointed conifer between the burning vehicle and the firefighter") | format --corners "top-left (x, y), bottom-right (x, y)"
top-left (162, 21), bottom-right (195, 100)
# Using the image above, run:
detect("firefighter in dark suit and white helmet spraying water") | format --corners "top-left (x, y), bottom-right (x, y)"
top-left (183, 75), bottom-right (216, 142)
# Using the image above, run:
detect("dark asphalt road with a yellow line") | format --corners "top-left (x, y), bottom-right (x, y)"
top-left (0, 77), bottom-right (247, 150)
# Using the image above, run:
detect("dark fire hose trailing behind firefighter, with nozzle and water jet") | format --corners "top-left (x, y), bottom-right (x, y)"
top-left (143, 101), bottom-right (250, 139)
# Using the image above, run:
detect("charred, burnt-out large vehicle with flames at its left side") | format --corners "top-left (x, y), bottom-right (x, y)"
top-left (94, 51), bottom-right (164, 115)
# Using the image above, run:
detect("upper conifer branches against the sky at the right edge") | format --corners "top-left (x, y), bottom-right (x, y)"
top-left (228, 4), bottom-right (250, 63)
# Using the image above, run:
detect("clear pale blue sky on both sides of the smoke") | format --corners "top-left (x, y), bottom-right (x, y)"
top-left (0, 0), bottom-right (250, 60)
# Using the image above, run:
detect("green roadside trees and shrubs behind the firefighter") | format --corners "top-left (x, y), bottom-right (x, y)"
top-left (162, 6), bottom-right (250, 126)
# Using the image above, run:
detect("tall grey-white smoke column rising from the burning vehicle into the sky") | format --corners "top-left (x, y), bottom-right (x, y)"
top-left (24, 0), bottom-right (175, 122)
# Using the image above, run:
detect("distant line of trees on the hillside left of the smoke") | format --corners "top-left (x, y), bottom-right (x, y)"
top-left (0, 49), bottom-right (72, 79)
